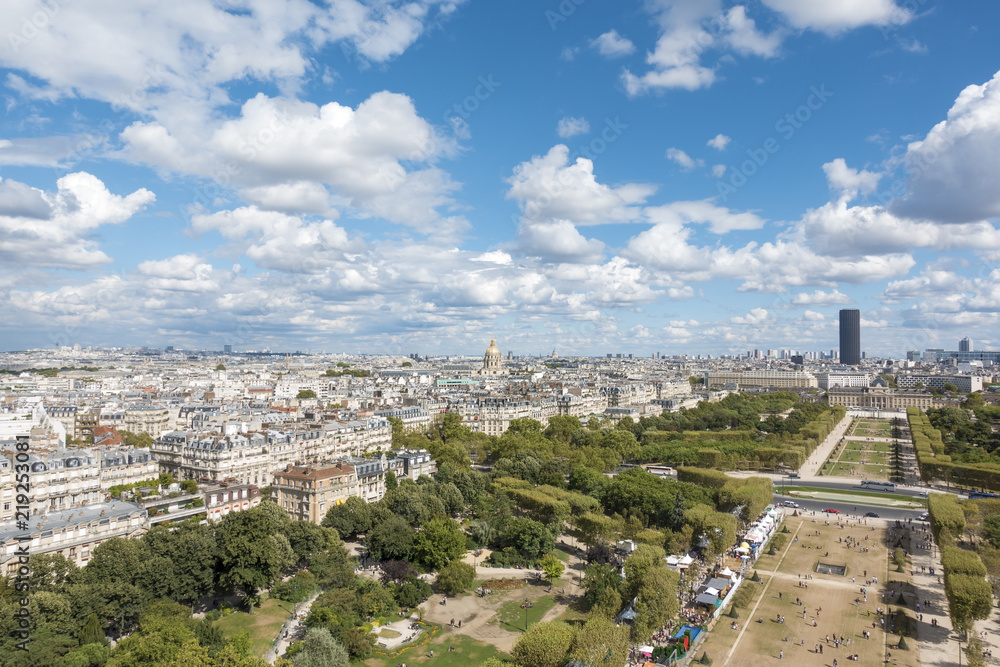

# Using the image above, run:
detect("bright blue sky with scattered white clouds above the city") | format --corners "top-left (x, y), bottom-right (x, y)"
top-left (0, 0), bottom-right (1000, 356)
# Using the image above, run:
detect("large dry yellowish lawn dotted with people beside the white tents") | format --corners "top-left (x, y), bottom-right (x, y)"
top-left (695, 516), bottom-right (919, 667)
